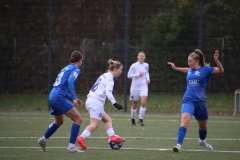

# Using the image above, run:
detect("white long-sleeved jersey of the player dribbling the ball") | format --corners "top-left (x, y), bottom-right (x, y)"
top-left (87, 72), bottom-right (116, 104)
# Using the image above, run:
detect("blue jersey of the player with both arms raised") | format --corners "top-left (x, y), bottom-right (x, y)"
top-left (183, 66), bottom-right (214, 102)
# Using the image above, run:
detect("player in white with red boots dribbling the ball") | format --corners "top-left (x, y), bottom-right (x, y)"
top-left (77, 59), bottom-right (123, 150)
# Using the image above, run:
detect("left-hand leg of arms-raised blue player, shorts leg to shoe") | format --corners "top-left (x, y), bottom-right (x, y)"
top-left (173, 103), bottom-right (194, 152)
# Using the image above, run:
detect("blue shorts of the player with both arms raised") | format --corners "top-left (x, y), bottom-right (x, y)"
top-left (181, 102), bottom-right (208, 121)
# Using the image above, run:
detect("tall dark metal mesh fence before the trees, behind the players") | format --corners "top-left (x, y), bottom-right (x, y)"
top-left (0, 0), bottom-right (240, 94)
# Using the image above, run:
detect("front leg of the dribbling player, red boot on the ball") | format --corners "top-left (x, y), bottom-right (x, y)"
top-left (102, 112), bottom-right (124, 144)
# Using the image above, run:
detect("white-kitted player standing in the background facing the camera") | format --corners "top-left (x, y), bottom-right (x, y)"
top-left (128, 51), bottom-right (150, 126)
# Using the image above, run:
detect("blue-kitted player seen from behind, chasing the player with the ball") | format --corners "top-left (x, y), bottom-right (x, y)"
top-left (38, 51), bottom-right (83, 152)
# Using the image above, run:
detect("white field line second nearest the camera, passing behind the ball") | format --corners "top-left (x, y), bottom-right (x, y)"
top-left (0, 137), bottom-right (240, 141)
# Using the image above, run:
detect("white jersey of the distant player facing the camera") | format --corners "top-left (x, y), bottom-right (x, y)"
top-left (128, 62), bottom-right (150, 90)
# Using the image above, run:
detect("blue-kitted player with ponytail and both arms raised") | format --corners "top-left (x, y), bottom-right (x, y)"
top-left (167, 49), bottom-right (224, 152)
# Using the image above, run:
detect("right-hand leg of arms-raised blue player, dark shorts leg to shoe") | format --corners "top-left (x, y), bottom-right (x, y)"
top-left (194, 102), bottom-right (213, 151)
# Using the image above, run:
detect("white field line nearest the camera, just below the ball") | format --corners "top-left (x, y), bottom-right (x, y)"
top-left (0, 147), bottom-right (240, 153)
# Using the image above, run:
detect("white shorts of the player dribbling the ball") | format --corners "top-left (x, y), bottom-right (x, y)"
top-left (86, 97), bottom-right (105, 121)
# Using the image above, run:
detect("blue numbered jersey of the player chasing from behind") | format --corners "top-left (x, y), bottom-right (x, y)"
top-left (49, 64), bottom-right (80, 100)
